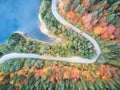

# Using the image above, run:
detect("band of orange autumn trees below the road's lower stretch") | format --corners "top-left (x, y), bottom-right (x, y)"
top-left (0, 64), bottom-right (118, 87)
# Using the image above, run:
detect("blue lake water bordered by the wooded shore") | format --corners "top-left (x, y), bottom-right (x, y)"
top-left (0, 0), bottom-right (50, 43)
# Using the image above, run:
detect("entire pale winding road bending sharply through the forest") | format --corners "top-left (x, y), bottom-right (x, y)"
top-left (0, 0), bottom-right (101, 63)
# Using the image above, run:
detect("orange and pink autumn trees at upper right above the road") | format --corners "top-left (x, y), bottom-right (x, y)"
top-left (58, 0), bottom-right (120, 41)
